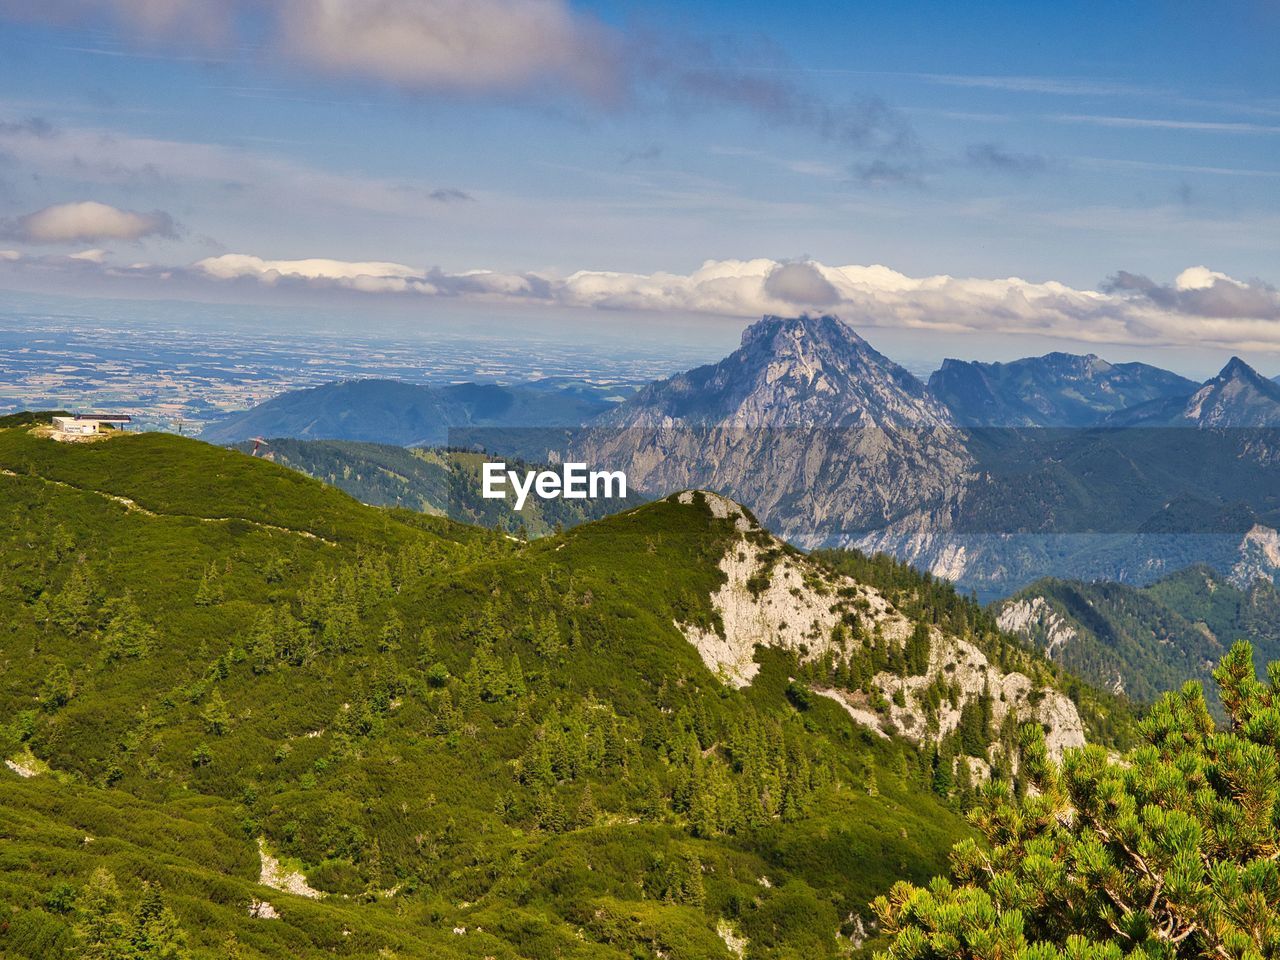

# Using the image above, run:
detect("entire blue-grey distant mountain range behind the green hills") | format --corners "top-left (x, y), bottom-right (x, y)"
top-left (206, 316), bottom-right (1280, 598)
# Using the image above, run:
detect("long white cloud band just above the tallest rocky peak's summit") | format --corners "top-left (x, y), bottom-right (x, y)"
top-left (183, 253), bottom-right (1280, 349)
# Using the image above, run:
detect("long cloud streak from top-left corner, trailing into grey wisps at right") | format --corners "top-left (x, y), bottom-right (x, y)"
top-left (0, 0), bottom-right (919, 163)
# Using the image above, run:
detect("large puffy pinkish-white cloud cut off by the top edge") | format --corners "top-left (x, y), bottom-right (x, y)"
top-left (278, 0), bottom-right (620, 97)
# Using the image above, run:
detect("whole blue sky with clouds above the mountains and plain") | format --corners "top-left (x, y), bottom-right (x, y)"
top-left (0, 0), bottom-right (1280, 372)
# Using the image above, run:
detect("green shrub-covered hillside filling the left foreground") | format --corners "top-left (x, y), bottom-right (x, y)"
top-left (0, 421), bottom-right (1136, 960)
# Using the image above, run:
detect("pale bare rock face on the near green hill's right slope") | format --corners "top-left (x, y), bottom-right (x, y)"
top-left (676, 493), bottom-right (1085, 756)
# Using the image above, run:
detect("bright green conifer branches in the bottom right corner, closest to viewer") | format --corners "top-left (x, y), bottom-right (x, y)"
top-left (874, 641), bottom-right (1280, 960)
